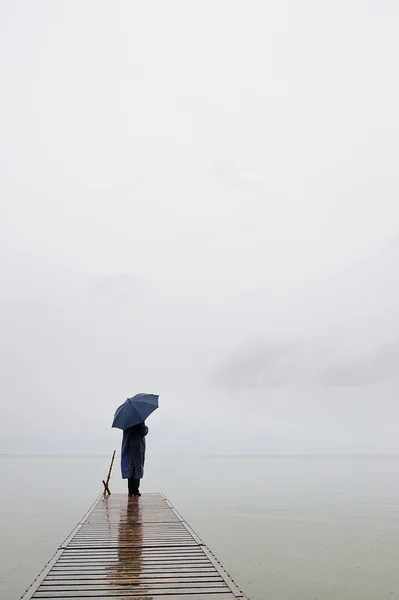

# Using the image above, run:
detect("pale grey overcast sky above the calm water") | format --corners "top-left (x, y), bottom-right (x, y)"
top-left (0, 0), bottom-right (399, 454)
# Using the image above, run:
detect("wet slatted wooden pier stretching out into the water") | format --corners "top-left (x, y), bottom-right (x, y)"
top-left (22, 494), bottom-right (246, 600)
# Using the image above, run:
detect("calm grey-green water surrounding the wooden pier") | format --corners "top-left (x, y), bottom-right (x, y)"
top-left (0, 455), bottom-right (399, 600)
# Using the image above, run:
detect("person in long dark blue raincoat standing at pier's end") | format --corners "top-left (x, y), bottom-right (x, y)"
top-left (121, 423), bottom-right (148, 497)
